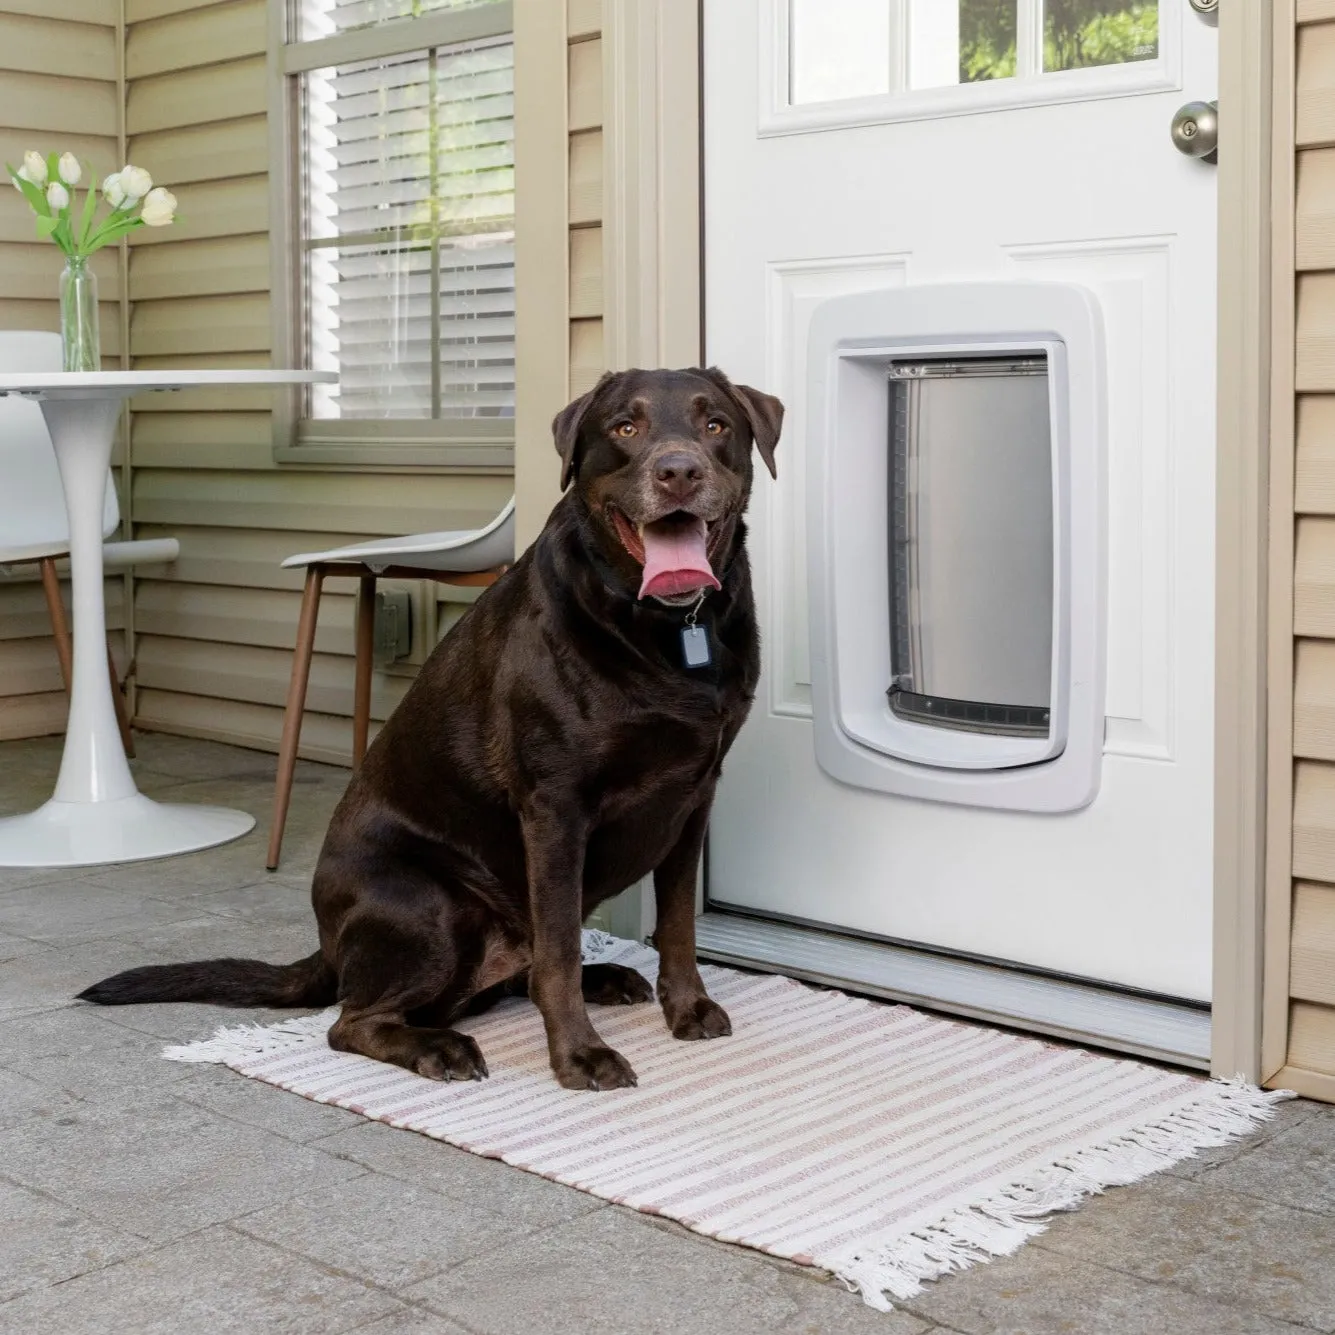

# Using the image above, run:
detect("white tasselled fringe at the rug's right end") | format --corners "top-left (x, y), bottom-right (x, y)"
top-left (833, 1076), bottom-right (1296, 1312)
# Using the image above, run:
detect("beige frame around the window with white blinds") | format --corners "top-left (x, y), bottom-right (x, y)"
top-left (267, 0), bottom-right (514, 473)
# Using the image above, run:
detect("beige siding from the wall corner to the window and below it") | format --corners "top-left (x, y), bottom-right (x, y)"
top-left (125, 0), bottom-right (513, 762)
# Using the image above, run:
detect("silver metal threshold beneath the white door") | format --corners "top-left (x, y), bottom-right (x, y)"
top-left (696, 912), bottom-right (1210, 1071)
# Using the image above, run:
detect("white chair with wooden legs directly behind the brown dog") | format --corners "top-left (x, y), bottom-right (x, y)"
top-left (266, 497), bottom-right (514, 872)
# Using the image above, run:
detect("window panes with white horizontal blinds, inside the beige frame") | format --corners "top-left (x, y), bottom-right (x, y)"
top-left (288, 0), bottom-right (514, 443)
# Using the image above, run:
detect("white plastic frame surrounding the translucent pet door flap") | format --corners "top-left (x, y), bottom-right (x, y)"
top-left (808, 282), bottom-right (1107, 812)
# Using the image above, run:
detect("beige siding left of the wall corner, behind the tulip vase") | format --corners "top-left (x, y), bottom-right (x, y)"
top-left (0, 0), bottom-right (124, 741)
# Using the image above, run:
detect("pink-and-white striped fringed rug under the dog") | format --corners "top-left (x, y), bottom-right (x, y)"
top-left (166, 933), bottom-right (1288, 1310)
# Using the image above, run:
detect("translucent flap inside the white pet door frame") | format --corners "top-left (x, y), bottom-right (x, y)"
top-left (886, 354), bottom-right (1053, 737)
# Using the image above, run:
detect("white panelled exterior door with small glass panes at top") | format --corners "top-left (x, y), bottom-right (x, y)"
top-left (704, 0), bottom-right (1227, 1001)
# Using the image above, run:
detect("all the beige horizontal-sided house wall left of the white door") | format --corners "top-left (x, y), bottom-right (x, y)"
top-left (0, 0), bottom-right (584, 761)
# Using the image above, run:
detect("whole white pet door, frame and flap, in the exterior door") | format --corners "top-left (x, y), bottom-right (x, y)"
top-left (805, 282), bottom-right (1107, 812)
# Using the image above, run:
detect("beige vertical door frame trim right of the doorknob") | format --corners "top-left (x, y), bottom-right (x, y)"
top-left (1217, 0), bottom-right (1276, 1080)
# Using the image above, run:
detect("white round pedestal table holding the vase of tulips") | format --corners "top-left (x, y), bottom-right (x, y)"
top-left (0, 371), bottom-right (338, 866)
